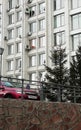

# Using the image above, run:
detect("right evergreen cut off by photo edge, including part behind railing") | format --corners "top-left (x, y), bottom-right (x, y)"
top-left (69, 46), bottom-right (81, 103)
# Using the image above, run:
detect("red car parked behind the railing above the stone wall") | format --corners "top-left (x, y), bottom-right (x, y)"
top-left (0, 81), bottom-right (40, 100)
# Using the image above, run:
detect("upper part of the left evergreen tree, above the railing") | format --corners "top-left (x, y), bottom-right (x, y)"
top-left (45, 46), bottom-right (68, 85)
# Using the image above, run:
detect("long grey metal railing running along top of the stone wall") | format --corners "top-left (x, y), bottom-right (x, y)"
top-left (0, 76), bottom-right (81, 103)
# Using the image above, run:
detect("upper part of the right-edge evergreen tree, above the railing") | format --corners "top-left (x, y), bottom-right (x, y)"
top-left (70, 46), bottom-right (81, 87)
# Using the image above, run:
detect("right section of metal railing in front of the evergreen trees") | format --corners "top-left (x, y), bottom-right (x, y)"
top-left (42, 82), bottom-right (81, 103)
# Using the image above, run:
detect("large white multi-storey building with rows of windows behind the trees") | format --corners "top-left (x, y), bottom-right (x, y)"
top-left (1, 0), bottom-right (81, 80)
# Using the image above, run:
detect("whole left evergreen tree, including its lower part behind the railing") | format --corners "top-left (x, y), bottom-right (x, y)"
top-left (45, 46), bottom-right (68, 101)
